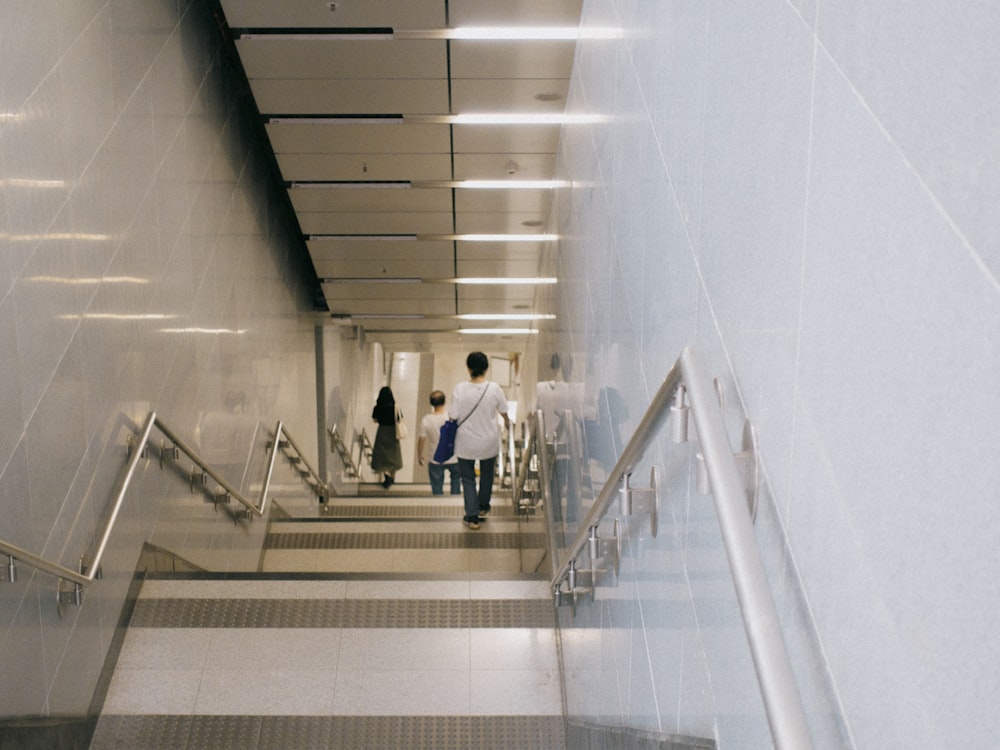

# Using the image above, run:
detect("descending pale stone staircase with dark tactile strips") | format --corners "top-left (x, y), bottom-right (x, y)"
top-left (91, 485), bottom-right (566, 750)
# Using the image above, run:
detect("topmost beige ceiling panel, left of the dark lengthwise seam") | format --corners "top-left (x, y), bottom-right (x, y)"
top-left (221, 0), bottom-right (450, 29)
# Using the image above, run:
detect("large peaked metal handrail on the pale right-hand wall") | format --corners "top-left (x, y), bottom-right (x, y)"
top-left (552, 347), bottom-right (813, 750)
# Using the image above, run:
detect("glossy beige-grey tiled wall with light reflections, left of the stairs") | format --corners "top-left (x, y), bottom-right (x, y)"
top-left (0, 0), bottom-right (317, 716)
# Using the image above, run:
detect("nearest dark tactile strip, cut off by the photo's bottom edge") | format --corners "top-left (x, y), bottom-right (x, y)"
top-left (90, 716), bottom-right (566, 750)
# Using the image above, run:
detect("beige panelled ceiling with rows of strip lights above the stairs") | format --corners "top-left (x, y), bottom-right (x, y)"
top-left (220, 0), bottom-right (582, 349)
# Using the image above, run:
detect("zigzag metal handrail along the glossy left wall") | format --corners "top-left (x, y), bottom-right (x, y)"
top-left (0, 412), bottom-right (322, 587)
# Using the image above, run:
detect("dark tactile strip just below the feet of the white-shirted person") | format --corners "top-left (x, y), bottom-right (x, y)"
top-left (264, 531), bottom-right (546, 549)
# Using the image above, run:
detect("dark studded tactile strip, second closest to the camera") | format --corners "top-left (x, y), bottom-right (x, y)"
top-left (130, 599), bottom-right (555, 628)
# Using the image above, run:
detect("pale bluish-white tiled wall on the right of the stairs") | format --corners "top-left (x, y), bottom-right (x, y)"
top-left (541, 0), bottom-right (1000, 749)
